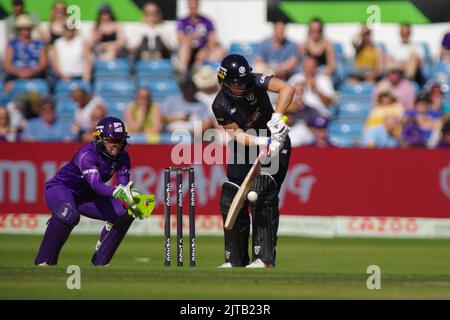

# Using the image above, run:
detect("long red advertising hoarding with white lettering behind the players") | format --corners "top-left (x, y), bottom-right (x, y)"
top-left (0, 143), bottom-right (450, 218)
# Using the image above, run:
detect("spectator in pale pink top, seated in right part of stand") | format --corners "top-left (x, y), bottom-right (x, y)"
top-left (372, 64), bottom-right (416, 110)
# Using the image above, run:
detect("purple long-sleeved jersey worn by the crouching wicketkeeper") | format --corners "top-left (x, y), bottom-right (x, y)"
top-left (46, 142), bottom-right (130, 197)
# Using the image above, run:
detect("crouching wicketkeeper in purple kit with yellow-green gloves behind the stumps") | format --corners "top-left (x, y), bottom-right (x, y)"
top-left (34, 117), bottom-right (154, 266)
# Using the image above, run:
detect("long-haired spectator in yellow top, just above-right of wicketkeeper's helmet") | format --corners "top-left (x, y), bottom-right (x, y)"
top-left (124, 87), bottom-right (163, 135)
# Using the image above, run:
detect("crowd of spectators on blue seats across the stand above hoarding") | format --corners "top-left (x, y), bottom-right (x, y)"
top-left (0, 0), bottom-right (450, 148)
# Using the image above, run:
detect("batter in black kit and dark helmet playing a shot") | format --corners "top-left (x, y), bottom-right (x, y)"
top-left (213, 54), bottom-right (294, 268)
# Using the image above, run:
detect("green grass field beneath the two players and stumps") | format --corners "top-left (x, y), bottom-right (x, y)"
top-left (0, 235), bottom-right (450, 300)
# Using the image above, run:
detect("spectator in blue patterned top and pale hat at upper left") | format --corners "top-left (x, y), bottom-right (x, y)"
top-left (4, 15), bottom-right (48, 92)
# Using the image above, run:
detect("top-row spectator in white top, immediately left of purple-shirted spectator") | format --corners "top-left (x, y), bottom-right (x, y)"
top-left (129, 2), bottom-right (175, 61)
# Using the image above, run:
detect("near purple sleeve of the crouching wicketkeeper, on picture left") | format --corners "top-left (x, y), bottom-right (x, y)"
top-left (78, 153), bottom-right (114, 198)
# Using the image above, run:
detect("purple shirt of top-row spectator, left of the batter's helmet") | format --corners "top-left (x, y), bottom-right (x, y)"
top-left (177, 15), bottom-right (214, 49)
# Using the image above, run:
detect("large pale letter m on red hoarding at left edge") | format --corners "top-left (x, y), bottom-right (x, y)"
top-left (0, 160), bottom-right (37, 203)
